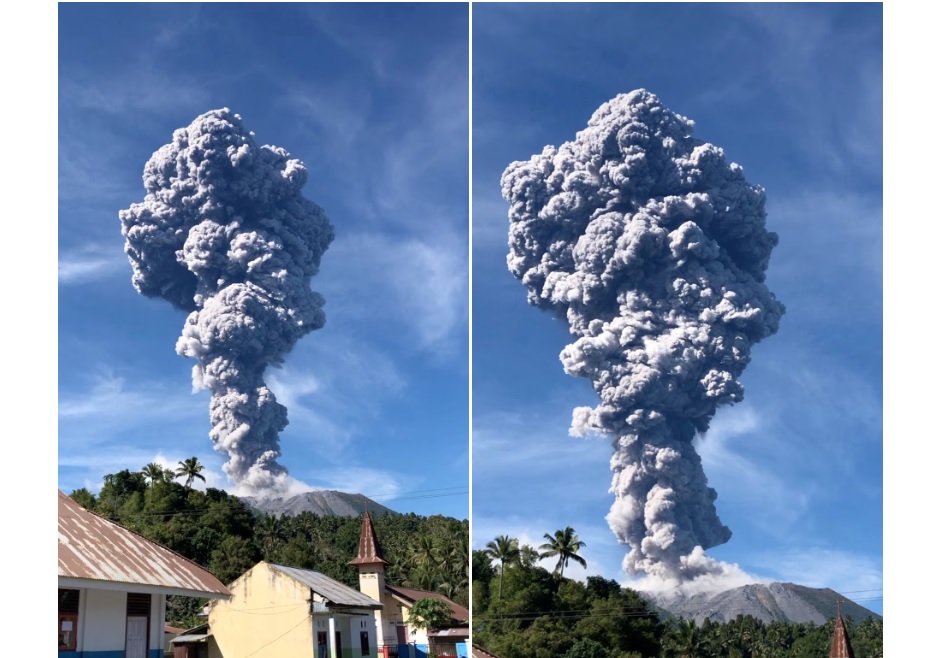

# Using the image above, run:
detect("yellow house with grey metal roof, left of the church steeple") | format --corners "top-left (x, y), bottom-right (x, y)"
top-left (207, 561), bottom-right (382, 658)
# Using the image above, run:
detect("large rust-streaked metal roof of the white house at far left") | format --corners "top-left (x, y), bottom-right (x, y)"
top-left (59, 491), bottom-right (230, 598)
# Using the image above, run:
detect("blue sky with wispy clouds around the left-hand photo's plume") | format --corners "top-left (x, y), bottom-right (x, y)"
top-left (58, 4), bottom-right (469, 518)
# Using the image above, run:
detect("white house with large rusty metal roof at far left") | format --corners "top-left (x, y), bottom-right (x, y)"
top-left (56, 491), bottom-right (229, 658)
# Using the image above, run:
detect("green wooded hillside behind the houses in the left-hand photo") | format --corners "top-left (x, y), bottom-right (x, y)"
top-left (70, 457), bottom-right (470, 628)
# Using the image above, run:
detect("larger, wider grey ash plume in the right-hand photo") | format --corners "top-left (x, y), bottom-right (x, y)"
top-left (501, 90), bottom-right (784, 581)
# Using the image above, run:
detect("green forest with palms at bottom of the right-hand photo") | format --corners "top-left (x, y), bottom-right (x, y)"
top-left (471, 528), bottom-right (882, 658)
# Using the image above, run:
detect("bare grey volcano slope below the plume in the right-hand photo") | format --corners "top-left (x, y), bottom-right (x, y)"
top-left (640, 583), bottom-right (879, 624)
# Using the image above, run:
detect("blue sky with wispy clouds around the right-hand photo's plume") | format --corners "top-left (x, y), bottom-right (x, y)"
top-left (472, 3), bottom-right (883, 613)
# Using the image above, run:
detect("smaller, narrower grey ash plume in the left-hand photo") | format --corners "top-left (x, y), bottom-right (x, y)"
top-left (120, 108), bottom-right (333, 492)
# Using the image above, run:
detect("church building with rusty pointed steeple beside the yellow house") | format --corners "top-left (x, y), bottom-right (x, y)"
top-left (350, 511), bottom-right (470, 658)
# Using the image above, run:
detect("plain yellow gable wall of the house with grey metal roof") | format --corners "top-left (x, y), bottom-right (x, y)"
top-left (209, 562), bottom-right (314, 658)
